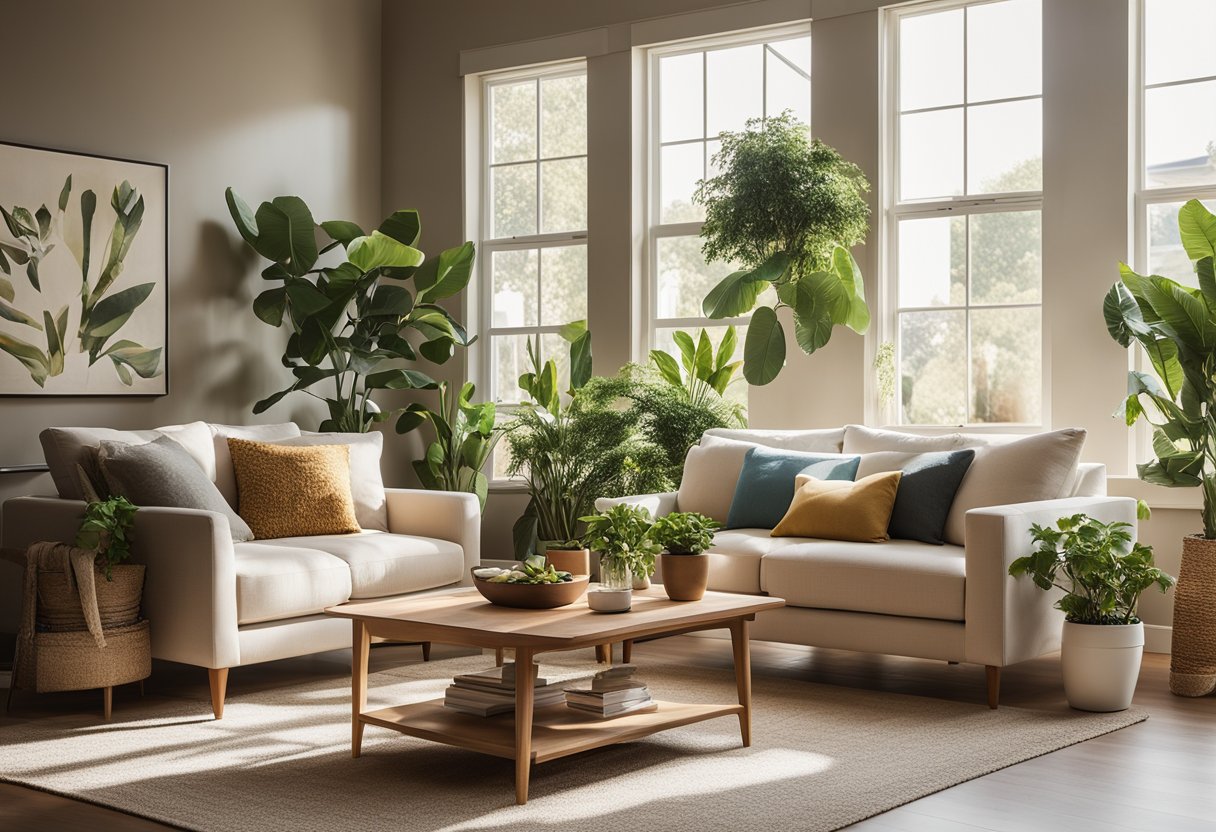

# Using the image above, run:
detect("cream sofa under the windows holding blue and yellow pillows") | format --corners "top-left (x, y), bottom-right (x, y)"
top-left (596, 426), bottom-right (1136, 708)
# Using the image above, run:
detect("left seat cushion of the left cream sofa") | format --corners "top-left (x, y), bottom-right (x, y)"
top-left (232, 541), bottom-right (350, 624)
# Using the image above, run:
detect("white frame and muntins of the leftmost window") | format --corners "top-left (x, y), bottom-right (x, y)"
top-left (477, 60), bottom-right (590, 408)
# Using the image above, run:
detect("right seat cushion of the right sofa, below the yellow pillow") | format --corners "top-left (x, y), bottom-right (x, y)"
top-left (760, 540), bottom-right (966, 622)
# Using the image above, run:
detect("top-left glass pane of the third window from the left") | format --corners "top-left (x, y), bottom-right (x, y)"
top-left (900, 9), bottom-right (963, 111)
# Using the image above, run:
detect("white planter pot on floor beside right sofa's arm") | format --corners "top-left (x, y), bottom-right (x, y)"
top-left (1060, 622), bottom-right (1144, 712)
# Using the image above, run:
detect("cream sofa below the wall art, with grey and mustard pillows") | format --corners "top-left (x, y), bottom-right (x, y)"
top-left (0, 423), bottom-right (482, 719)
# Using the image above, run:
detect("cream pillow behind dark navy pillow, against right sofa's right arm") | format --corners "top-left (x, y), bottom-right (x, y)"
top-left (945, 428), bottom-right (1086, 546)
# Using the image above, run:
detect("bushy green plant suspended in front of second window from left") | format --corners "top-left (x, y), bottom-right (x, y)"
top-left (693, 112), bottom-right (869, 384)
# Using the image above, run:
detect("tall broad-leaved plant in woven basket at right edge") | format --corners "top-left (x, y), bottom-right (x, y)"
top-left (1103, 199), bottom-right (1216, 696)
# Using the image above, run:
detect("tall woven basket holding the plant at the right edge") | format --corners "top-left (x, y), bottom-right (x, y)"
top-left (1170, 534), bottom-right (1216, 696)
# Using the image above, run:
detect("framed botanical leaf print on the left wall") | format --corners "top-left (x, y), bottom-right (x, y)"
top-left (0, 142), bottom-right (169, 395)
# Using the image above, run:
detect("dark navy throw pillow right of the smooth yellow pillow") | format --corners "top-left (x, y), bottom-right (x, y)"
top-left (886, 450), bottom-right (975, 546)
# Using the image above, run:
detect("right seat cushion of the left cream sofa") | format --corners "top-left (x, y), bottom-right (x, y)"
top-left (259, 532), bottom-right (465, 598)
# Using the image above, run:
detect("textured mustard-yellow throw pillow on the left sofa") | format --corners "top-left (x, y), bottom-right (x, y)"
top-left (227, 439), bottom-right (360, 540)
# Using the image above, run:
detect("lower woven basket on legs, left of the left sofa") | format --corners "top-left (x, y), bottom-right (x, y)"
top-left (33, 620), bottom-right (152, 693)
